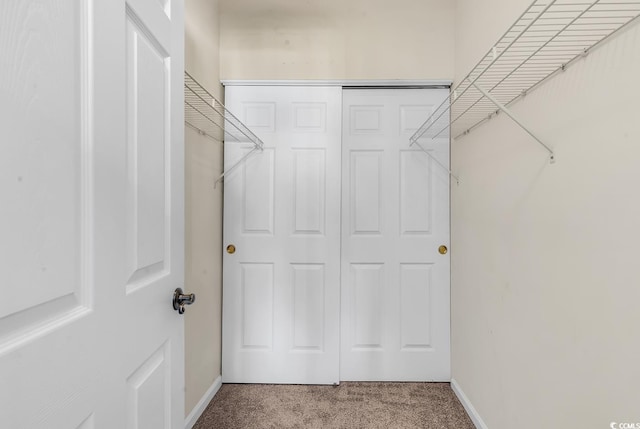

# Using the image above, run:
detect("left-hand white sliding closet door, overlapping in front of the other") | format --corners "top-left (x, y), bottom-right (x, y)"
top-left (222, 86), bottom-right (342, 384)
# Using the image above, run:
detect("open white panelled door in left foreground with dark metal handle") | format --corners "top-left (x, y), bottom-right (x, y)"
top-left (0, 0), bottom-right (184, 429)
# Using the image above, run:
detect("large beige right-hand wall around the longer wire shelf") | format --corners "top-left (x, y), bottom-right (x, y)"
top-left (451, 0), bottom-right (640, 429)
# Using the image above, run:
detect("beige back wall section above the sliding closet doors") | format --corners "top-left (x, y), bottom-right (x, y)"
top-left (220, 0), bottom-right (455, 80)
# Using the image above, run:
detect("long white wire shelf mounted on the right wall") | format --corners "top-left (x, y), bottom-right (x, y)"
top-left (411, 0), bottom-right (640, 144)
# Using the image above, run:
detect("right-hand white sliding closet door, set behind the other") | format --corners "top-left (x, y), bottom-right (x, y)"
top-left (340, 89), bottom-right (450, 381)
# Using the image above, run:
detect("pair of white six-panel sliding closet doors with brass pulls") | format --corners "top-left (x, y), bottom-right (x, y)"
top-left (222, 86), bottom-right (450, 384)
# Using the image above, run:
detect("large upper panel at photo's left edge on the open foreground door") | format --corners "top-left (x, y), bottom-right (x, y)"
top-left (0, 0), bottom-right (94, 354)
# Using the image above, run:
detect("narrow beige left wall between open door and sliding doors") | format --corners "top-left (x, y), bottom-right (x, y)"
top-left (185, 0), bottom-right (222, 414)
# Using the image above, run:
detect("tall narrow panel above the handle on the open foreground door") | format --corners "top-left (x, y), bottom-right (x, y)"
top-left (127, 15), bottom-right (171, 293)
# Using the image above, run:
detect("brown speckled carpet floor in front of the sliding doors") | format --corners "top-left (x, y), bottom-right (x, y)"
top-left (194, 382), bottom-right (475, 429)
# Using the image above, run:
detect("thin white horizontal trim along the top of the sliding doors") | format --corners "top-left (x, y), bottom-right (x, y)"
top-left (222, 79), bottom-right (453, 87)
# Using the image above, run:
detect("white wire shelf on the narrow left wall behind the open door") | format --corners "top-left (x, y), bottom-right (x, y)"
top-left (184, 72), bottom-right (264, 183)
